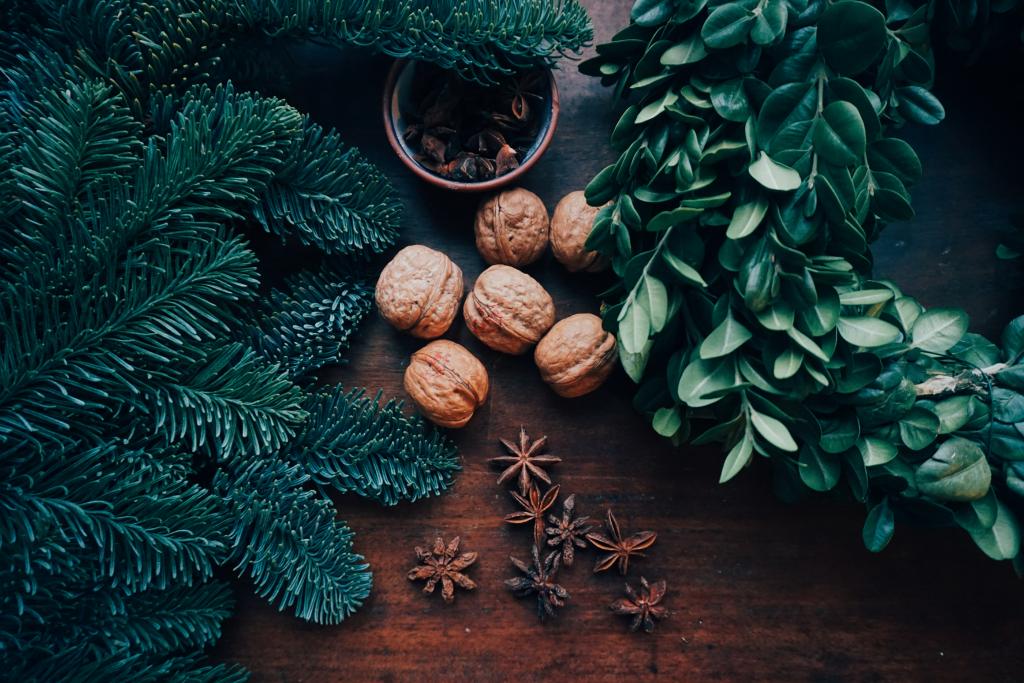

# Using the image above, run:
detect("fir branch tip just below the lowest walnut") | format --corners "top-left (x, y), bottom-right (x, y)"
top-left (286, 387), bottom-right (460, 505)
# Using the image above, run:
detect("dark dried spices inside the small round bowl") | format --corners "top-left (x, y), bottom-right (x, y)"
top-left (402, 65), bottom-right (549, 182)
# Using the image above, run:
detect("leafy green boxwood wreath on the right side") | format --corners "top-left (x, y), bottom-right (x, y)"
top-left (581, 0), bottom-right (1024, 571)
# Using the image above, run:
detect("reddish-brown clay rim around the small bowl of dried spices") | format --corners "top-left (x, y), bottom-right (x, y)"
top-left (381, 59), bottom-right (560, 193)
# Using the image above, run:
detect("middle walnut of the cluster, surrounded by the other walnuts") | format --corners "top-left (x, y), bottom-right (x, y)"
top-left (462, 265), bottom-right (555, 355)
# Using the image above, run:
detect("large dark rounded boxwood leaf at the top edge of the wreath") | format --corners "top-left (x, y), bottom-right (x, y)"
top-left (817, 0), bottom-right (887, 76)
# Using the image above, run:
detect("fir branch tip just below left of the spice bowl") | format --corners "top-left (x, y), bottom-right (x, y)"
top-left (254, 119), bottom-right (400, 255)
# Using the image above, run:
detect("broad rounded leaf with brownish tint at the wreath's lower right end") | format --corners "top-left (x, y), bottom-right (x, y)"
top-left (914, 436), bottom-right (992, 502)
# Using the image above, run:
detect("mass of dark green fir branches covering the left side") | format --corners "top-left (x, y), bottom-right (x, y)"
top-left (0, 0), bottom-right (591, 682)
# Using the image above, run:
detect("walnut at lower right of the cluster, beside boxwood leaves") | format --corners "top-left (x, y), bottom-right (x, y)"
top-left (534, 313), bottom-right (615, 398)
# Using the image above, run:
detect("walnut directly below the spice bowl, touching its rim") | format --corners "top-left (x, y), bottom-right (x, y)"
top-left (473, 187), bottom-right (549, 266)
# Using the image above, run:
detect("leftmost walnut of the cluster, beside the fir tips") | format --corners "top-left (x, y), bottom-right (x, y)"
top-left (376, 245), bottom-right (462, 339)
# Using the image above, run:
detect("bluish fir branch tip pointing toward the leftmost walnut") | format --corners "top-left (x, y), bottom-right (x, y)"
top-left (247, 265), bottom-right (373, 379)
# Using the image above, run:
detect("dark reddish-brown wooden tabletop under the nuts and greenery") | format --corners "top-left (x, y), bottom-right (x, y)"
top-left (215, 0), bottom-right (1024, 682)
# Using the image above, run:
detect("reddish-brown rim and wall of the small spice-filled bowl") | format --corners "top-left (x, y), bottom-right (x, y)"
top-left (383, 59), bottom-right (558, 193)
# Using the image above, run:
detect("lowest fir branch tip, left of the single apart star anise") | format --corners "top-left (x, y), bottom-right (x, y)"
top-left (216, 460), bottom-right (372, 624)
